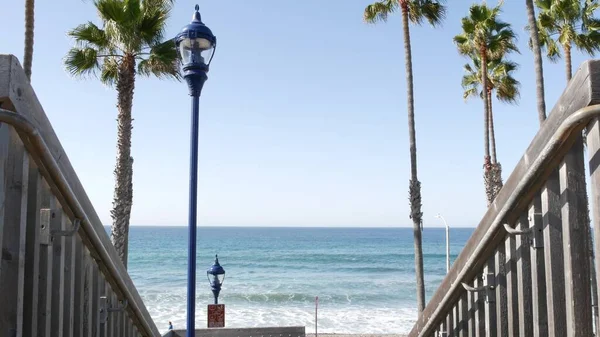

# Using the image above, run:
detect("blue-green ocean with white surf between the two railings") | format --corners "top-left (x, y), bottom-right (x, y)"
top-left (129, 226), bottom-right (473, 334)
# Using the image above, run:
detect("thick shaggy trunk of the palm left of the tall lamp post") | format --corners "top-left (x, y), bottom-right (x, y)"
top-left (111, 55), bottom-right (135, 267)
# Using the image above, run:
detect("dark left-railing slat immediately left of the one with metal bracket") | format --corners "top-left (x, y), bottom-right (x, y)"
top-left (23, 166), bottom-right (44, 336)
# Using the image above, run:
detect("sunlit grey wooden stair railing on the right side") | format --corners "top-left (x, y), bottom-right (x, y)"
top-left (409, 61), bottom-right (600, 337)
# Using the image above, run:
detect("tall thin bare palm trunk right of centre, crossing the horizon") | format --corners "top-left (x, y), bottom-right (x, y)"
top-left (400, 0), bottom-right (425, 315)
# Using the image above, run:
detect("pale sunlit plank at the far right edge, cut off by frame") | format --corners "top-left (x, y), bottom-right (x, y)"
top-left (585, 118), bottom-right (600, 331)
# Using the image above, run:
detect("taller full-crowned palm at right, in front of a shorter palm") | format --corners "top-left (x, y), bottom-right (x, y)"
top-left (454, 2), bottom-right (518, 206)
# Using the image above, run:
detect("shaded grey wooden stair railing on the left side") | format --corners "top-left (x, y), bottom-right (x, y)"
top-left (0, 55), bottom-right (160, 337)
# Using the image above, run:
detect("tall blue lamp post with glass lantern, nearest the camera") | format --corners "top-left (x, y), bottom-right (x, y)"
top-left (175, 5), bottom-right (217, 337)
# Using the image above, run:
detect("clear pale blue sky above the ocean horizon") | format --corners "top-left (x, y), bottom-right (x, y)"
top-left (0, 0), bottom-right (587, 226)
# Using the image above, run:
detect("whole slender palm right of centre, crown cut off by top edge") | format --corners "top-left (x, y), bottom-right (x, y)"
top-left (364, 0), bottom-right (446, 313)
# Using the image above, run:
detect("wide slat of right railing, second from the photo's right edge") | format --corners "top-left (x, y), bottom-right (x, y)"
top-left (559, 136), bottom-right (593, 337)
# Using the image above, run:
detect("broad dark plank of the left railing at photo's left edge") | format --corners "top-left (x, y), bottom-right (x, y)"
top-left (0, 125), bottom-right (28, 336)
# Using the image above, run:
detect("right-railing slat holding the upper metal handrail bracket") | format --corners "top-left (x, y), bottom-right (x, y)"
top-left (528, 196), bottom-right (548, 337)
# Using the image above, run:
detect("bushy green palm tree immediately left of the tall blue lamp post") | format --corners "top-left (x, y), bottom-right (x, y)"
top-left (65, 0), bottom-right (180, 266)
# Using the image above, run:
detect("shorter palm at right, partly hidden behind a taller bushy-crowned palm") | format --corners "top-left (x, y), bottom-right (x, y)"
top-left (462, 56), bottom-right (520, 197)
